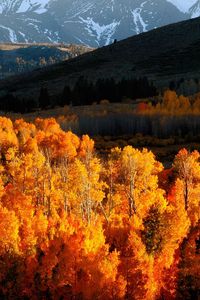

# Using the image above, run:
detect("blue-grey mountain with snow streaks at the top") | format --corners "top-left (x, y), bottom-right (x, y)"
top-left (0, 0), bottom-right (200, 47)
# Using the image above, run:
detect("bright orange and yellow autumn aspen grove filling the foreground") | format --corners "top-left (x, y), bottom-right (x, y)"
top-left (0, 116), bottom-right (200, 300)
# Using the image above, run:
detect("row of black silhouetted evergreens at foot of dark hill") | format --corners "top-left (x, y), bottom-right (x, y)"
top-left (0, 77), bottom-right (157, 113)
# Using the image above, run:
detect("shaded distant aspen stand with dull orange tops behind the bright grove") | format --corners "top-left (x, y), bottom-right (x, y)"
top-left (55, 90), bottom-right (200, 141)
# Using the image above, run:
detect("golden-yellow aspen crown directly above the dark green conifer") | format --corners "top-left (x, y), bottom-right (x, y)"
top-left (116, 146), bottom-right (163, 217)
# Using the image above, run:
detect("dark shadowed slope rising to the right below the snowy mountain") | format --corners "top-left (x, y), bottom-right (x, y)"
top-left (0, 18), bottom-right (200, 108)
